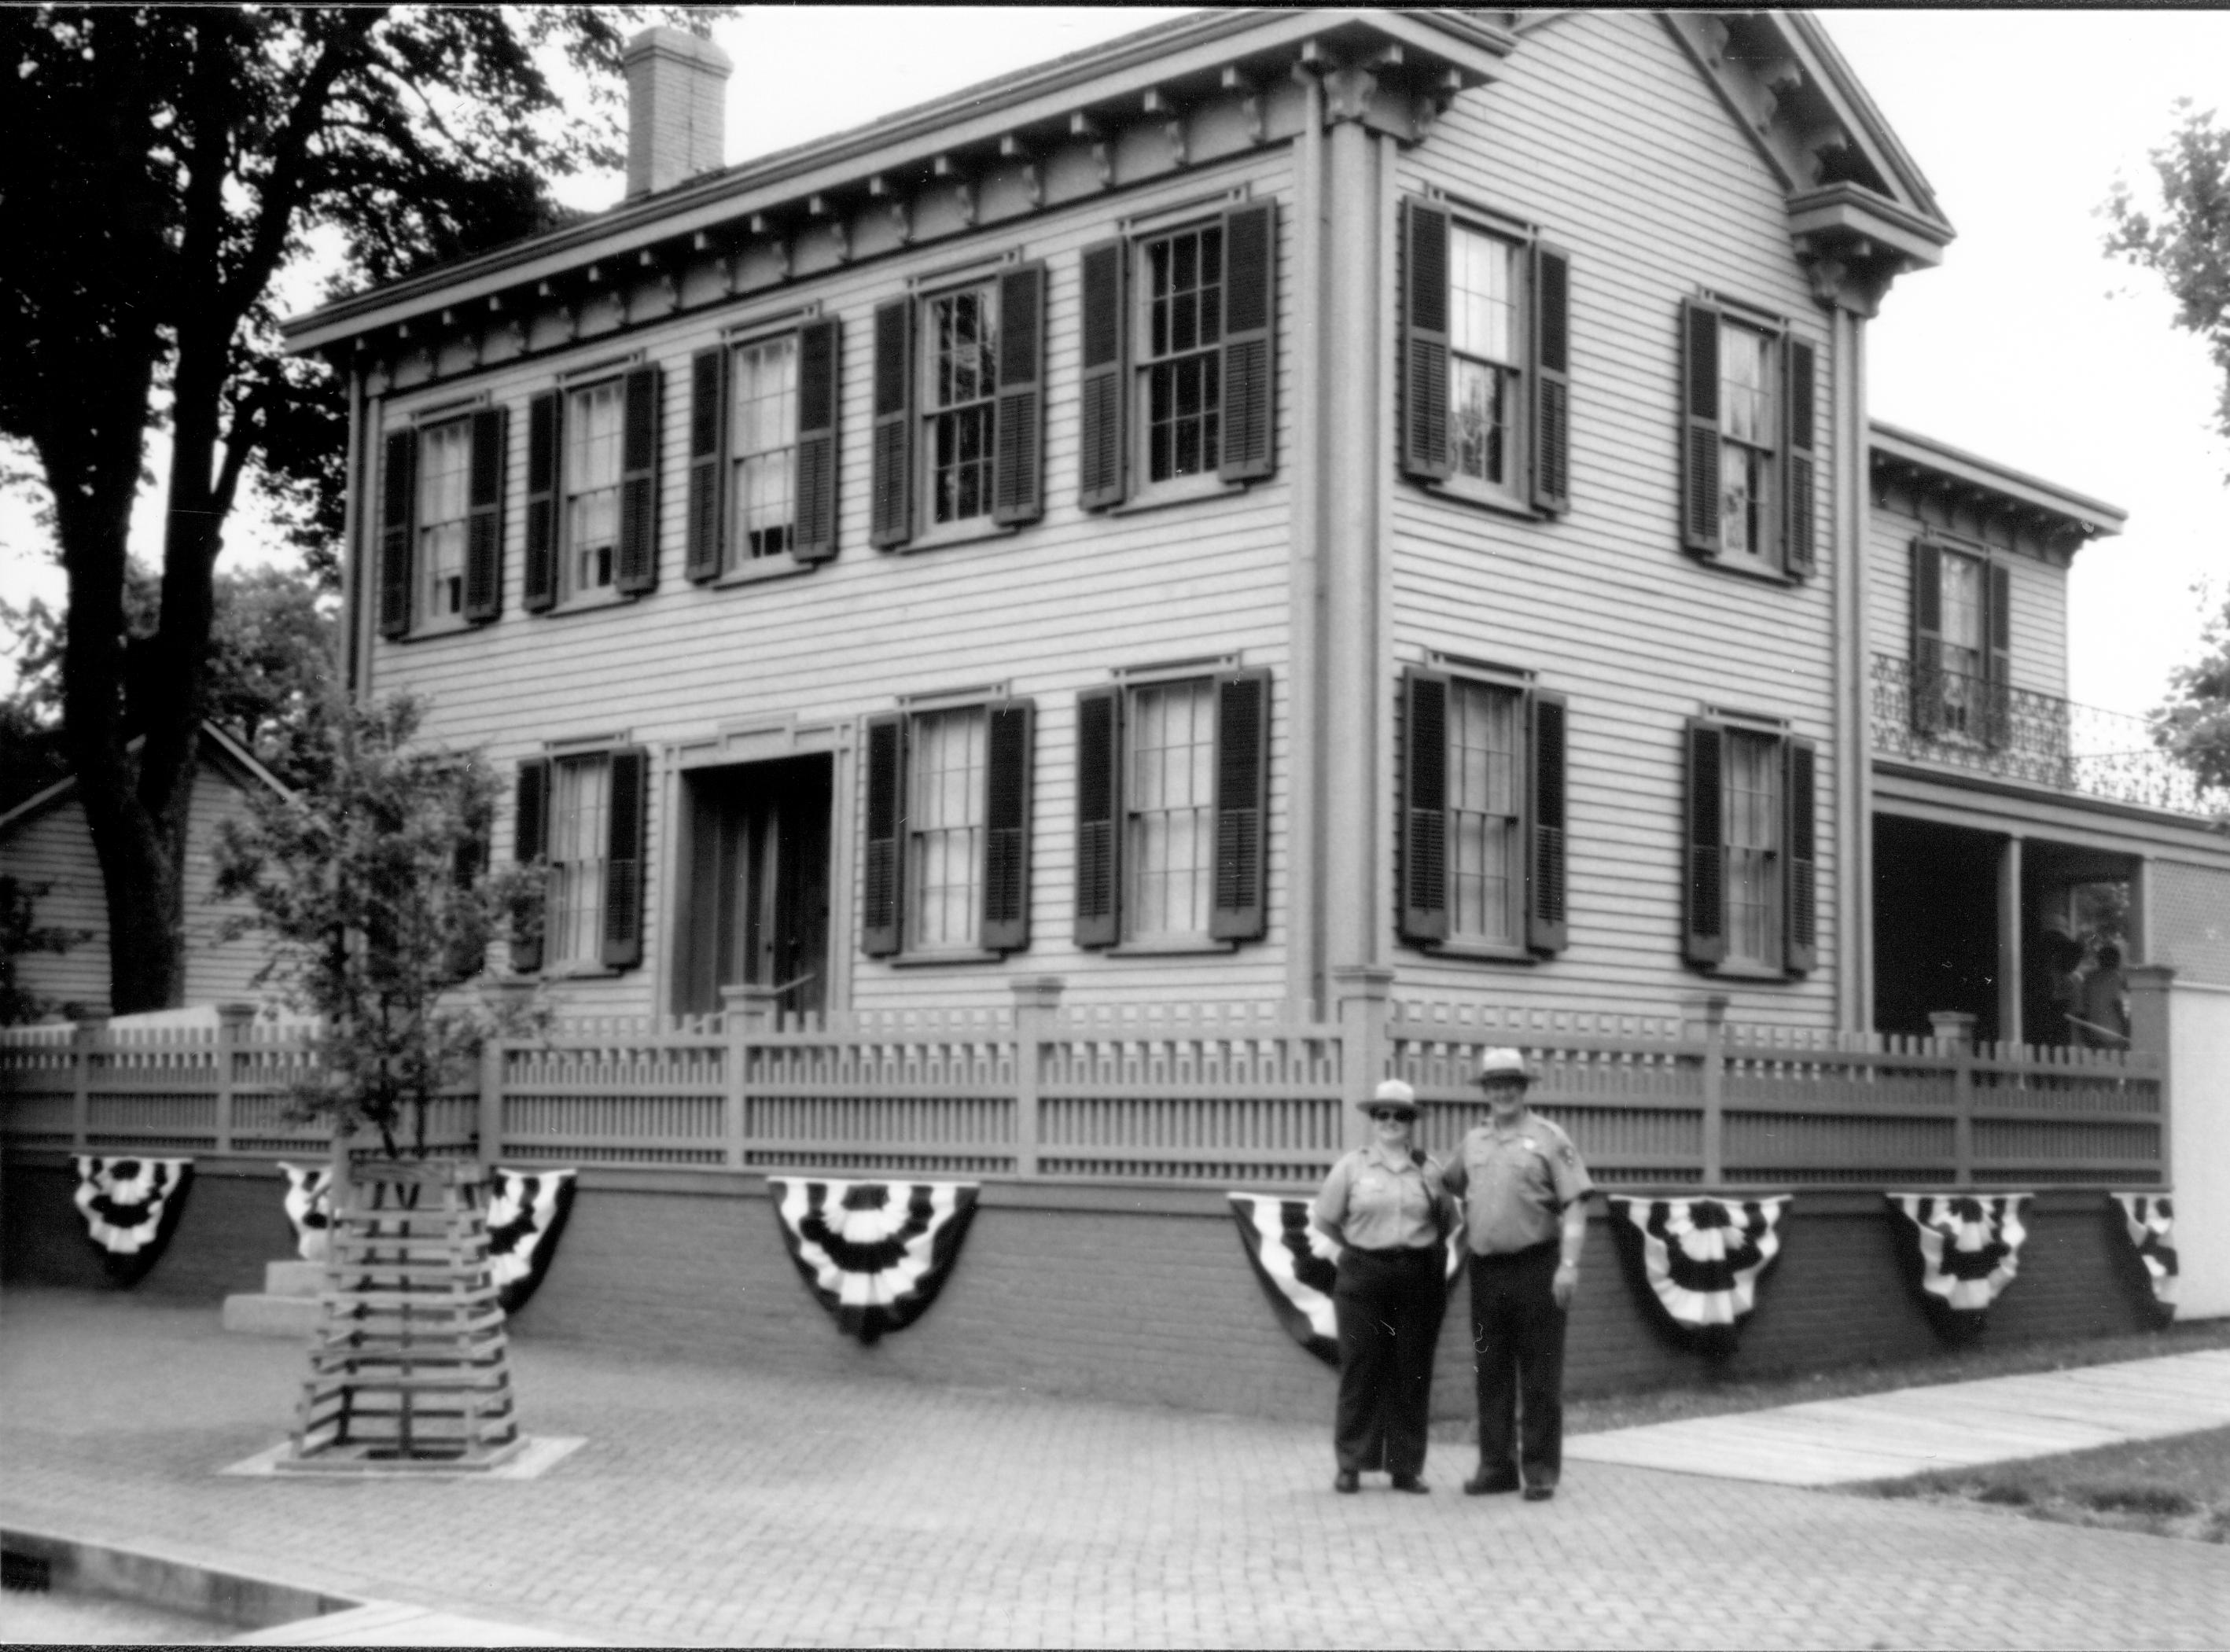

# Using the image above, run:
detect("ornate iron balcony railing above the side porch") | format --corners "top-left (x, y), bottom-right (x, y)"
top-left (1871, 653), bottom-right (2230, 816)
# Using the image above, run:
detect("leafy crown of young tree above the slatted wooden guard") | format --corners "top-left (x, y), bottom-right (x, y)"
top-left (216, 696), bottom-right (542, 1157)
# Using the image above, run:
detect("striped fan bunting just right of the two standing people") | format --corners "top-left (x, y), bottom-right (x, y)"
top-left (1610, 1193), bottom-right (1788, 1353)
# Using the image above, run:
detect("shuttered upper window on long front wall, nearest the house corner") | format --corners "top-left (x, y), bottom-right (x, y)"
top-left (1077, 201), bottom-right (1278, 508)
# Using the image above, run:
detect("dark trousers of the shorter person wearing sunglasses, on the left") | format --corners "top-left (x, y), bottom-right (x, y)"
top-left (1331, 1244), bottom-right (1448, 1474)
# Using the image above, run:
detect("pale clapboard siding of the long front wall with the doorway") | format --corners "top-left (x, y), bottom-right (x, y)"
top-left (373, 147), bottom-right (1298, 1014)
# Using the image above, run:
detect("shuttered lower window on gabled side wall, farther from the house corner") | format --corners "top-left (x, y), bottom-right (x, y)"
top-left (1686, 718), bottom-right (1817, 974)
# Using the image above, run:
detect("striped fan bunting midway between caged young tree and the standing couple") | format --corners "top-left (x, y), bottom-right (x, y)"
top-left (767, 1175), bottom-right (977, 1342)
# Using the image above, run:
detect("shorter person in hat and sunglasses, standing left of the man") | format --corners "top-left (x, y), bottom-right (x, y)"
top-left (1309, 1079), bottom-right (1456, 1492)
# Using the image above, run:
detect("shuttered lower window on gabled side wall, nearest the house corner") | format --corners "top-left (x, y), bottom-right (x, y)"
top-left (1398, 667), bottom-right (1566, 956)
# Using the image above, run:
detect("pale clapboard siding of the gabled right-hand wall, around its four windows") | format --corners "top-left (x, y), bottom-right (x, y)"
top-left (1387, 11), bottom-right (1838, 1025)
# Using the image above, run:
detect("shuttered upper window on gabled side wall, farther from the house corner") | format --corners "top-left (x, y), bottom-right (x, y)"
top-left (1681, 299), bottom-right (1820, 579)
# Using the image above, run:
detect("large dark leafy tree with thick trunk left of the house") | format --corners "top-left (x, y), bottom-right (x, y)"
top-left (0, 7), bottom-right (702, 1012)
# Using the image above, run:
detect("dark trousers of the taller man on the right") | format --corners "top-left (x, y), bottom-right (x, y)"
top-left (1472, 1239), bottom-right (1568, 1485)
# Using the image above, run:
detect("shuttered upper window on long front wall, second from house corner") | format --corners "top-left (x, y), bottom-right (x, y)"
top-left (867, 263), bottom-right (1046, 548)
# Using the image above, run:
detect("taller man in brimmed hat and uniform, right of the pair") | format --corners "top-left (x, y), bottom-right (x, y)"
top-left (1443, 1050), bottom-right (1595, 1503)
